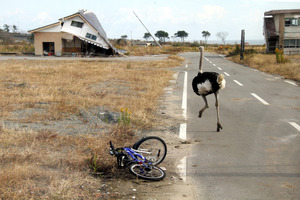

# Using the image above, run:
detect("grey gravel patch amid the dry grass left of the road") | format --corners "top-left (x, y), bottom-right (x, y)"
top-left (2, 107), bottom-right (120, 134)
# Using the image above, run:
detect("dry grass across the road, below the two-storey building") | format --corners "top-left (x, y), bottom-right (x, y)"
top-left (229, 54), bottom-right (300, 81)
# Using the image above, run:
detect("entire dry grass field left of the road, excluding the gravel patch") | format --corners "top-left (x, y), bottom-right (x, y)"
top-left (0, 56), bottom-right (181, 199)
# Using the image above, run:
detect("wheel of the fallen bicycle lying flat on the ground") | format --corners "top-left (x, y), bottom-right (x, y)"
top-left (129, 163), bottom-right (166, 181)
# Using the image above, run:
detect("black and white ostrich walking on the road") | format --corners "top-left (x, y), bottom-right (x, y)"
top-left (192, 46), bottom-right (226, 132)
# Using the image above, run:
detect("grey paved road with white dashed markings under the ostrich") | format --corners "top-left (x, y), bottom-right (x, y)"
top-left (179, 52), bottom-right (300, 200)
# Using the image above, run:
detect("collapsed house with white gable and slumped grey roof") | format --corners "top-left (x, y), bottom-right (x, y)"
top-left (28, 10), bottom-right (117, 56)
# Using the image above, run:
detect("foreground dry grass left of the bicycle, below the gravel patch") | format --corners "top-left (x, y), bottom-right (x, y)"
top-left (0, 128), bottom-right (122, 199)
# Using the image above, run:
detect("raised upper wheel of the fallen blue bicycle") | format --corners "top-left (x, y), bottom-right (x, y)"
top-left (133, 136), bottom-right (167, 165)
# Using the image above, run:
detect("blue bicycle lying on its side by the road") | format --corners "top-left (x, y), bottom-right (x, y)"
top-left (109, 136), bottom-right (167, 181)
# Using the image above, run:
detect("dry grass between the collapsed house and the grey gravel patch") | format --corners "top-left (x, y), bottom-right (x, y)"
top-left (0, 58), bottom-right (180, 126)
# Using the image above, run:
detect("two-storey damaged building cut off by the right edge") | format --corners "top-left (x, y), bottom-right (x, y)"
top-left (264, 9), bottom-right (300, 54)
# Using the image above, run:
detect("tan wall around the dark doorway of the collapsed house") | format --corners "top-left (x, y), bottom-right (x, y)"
top-left (34, 32), bottom-right (62, 56)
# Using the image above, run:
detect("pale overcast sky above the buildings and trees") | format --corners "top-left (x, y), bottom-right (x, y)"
top-left (0, 0), bottom-right (300, 41)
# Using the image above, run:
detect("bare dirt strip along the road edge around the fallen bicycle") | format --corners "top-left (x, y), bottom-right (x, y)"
top-left (98, 72), bottom-right (200, 200)
